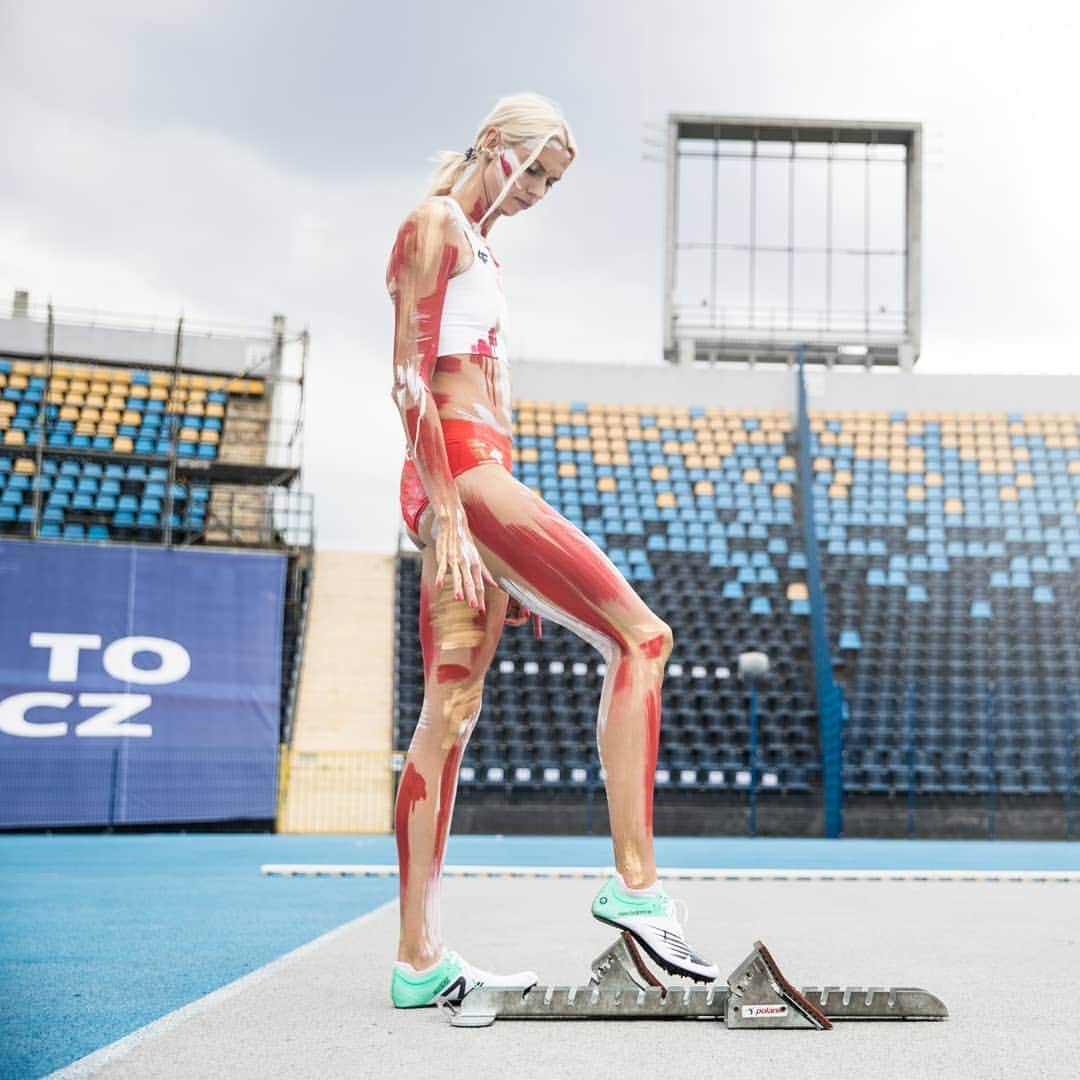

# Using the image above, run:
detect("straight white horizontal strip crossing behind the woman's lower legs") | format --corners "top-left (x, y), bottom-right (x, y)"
top-left (259, 863), bottom-right (1080, 883)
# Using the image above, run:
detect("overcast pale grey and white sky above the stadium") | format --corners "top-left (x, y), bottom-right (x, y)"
top-left (0, 0), bottom-right (1080, 551)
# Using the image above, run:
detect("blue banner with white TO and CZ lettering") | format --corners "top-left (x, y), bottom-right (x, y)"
top-left (0, 540), bottom-right (285, 828)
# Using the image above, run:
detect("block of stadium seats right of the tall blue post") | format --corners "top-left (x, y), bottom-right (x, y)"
top-left (811, 410), bottom-right (1080, 795)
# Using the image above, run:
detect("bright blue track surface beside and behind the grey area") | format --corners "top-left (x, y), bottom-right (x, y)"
top-left (0, 834), bottom-right (1080, 1080)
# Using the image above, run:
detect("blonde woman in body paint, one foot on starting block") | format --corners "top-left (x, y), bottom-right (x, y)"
top-left (387, 94), bottom-right (717, 1008)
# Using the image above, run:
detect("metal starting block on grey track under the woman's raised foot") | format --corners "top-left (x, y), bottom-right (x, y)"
top-left (443, 931), bottom-right (948, 1031)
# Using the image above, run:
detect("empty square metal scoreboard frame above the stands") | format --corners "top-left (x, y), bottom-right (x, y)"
top-left (664, 113), bottom-right (922, 368)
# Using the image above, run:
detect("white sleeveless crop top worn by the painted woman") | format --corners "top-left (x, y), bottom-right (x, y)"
top-left (434, 195), bottom-right (509, 361)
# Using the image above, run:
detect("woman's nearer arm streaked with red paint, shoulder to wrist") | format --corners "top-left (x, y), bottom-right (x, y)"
top-left (387, 202), bottom-right (463, 523)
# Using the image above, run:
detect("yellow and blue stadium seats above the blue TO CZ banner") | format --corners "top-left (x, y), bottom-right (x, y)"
top-left (0, 357), bottom-right (266, 542)
